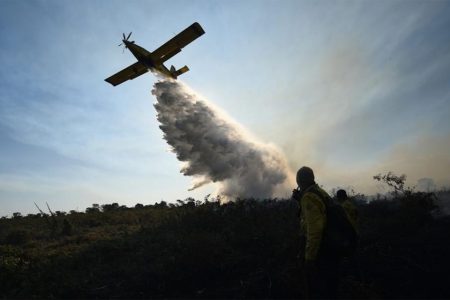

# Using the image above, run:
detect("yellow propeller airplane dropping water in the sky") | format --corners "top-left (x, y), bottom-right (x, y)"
top-left (105, 22), bottom-right (205, 86)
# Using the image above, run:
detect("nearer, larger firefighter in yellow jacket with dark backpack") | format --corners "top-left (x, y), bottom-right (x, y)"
top-left (292, 167), bottom-right (357, 299)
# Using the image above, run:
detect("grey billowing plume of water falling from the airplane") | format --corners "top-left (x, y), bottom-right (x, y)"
top-left (152, 80), bottom-right (290, 199)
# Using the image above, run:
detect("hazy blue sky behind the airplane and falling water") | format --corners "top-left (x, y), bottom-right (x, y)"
top-left (0, 0), bottom-right (450, 215)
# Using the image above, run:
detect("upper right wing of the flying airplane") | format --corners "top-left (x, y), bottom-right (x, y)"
top-left (151, 22), bottom-right (205, 63)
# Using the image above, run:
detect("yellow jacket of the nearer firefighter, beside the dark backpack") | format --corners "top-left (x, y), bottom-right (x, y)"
top-left (300, 193), bottom-right (326, 260)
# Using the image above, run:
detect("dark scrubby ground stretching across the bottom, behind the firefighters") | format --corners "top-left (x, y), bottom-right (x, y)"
top-left (0, 192), bottom-right (450, 298)
